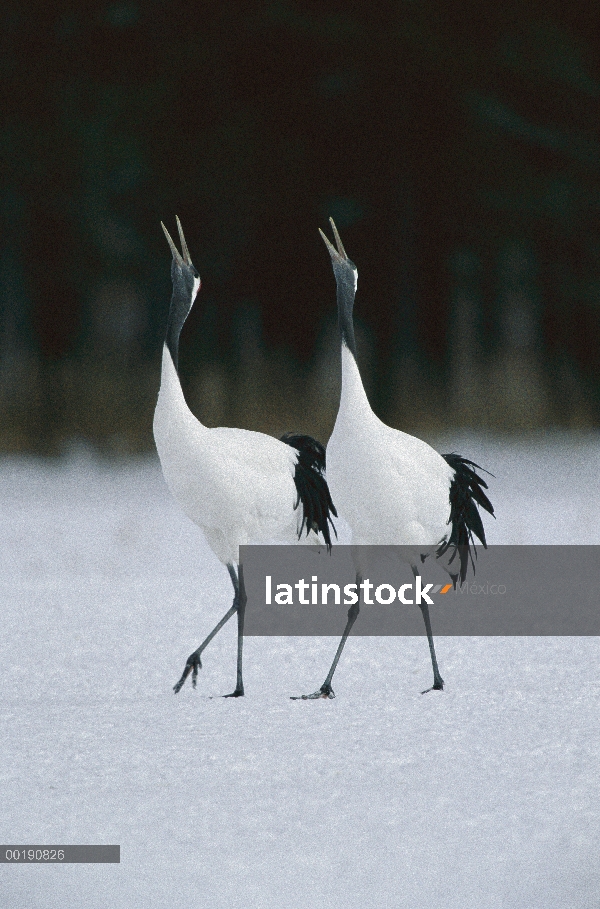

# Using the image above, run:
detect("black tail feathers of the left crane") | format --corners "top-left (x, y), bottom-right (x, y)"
top-left (281, 432), bottom-right (337, 551)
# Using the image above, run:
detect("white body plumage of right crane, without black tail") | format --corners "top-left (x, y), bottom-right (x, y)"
top-left (327, 344), bottom-right (454, 552)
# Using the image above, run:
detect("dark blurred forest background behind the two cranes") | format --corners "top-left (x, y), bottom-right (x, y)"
top-left (0, 0), bottom-right (600, 452)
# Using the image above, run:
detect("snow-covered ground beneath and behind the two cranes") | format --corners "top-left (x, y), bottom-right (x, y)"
top-left (0, 436), bottom-right (600, 909)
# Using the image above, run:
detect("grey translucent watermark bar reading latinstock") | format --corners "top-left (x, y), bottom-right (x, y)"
top-left (240, 546), bottom-right (600, 637)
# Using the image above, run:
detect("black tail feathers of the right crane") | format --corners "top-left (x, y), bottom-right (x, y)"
top-left (437, 453), bottom-right (495, 588)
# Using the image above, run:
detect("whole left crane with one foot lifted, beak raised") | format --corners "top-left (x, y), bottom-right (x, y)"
top-left (154, 218), bottom-right (336, 697)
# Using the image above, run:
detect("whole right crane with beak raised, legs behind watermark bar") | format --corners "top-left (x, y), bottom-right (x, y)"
top-left (292, 218), bottom-right (494, 699)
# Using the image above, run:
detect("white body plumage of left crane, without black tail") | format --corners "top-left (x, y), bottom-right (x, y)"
top-left (154, 345), bottom-right (304, 565)
